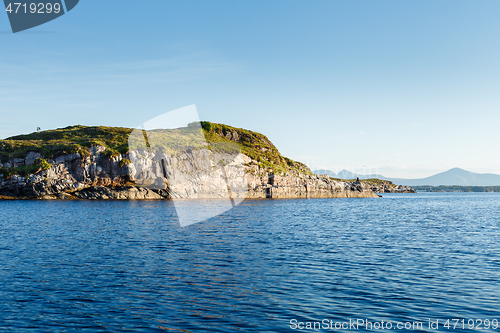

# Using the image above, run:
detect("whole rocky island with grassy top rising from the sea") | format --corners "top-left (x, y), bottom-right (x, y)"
top-left (0, 122), bottom-right (377, 200)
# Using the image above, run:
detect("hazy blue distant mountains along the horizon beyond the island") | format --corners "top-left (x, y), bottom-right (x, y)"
top-left (313, 168), bottom-right (500, 186)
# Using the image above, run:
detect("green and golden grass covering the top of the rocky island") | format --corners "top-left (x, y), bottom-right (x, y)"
top-left (0, 121), bottom-right (312, 174)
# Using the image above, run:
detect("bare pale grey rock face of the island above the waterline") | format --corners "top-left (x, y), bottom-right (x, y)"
top-left (0, 146), bottom-right (378, 200)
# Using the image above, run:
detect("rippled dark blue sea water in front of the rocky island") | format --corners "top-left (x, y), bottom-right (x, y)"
top-left (0, 193), bottom-right (500, 332)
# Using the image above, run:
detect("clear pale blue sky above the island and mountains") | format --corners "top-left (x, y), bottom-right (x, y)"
top-left (0, 0), bottom-right (500, 178)
